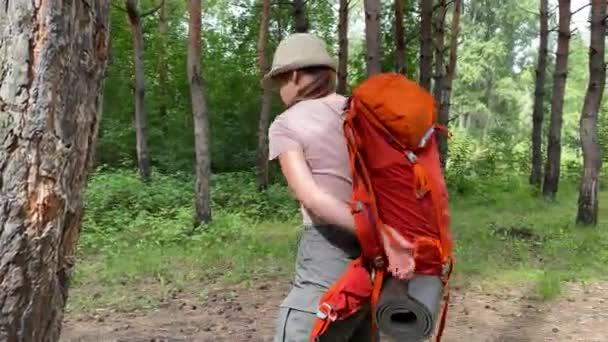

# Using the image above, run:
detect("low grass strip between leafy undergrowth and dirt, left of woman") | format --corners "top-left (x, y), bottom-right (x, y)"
top-left (70, 218), bottom-right (297, 311)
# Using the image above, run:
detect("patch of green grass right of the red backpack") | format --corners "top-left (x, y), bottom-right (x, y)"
top-left (452, 182), bottom-right (608, 299)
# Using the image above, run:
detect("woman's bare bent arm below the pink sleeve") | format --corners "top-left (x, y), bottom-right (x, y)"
top-left (279, 149), bottom-right (355, 234)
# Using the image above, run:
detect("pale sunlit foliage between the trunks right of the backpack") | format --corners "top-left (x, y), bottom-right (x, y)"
top-left (452, 1), bottom-right (588, 184)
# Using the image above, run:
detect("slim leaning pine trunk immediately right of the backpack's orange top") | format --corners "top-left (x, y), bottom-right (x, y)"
top-left (439, 0), bottom-right (462, 167)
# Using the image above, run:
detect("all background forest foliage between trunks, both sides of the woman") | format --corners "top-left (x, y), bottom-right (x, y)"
top-left (97, 0), bottom-right (606, 184)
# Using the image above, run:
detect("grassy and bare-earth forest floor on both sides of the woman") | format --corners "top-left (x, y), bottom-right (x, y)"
top-left (62, 175), bottom-right (608, 342)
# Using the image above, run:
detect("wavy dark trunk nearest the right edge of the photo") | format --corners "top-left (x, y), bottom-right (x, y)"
top-left (576, 0), bottom-right (606, 225)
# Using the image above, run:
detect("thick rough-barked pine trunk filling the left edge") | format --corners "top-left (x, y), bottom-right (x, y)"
top-left (0, 0), bottom-right (109, 342)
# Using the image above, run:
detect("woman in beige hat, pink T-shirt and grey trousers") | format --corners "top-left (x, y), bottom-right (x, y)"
top-left (264, 33), bottom-right (372, 342)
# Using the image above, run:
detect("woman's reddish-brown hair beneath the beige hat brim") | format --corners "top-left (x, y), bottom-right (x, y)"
top-left (278, 66), bottom-right (336, 106)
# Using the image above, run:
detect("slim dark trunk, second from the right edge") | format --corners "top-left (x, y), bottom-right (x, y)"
top-left (543, 0), bottom-right (571, 200)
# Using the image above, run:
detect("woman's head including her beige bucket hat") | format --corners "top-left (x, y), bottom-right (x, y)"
top-left (263, 33), bottom-right (337, 106)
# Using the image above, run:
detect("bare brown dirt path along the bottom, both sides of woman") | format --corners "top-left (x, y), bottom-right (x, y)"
top-left (61, 283), bottom-right (608, 342)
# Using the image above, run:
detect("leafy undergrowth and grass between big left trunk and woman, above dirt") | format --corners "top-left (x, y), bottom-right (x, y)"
top-left (70, 170), bottom-right (299, 309)
